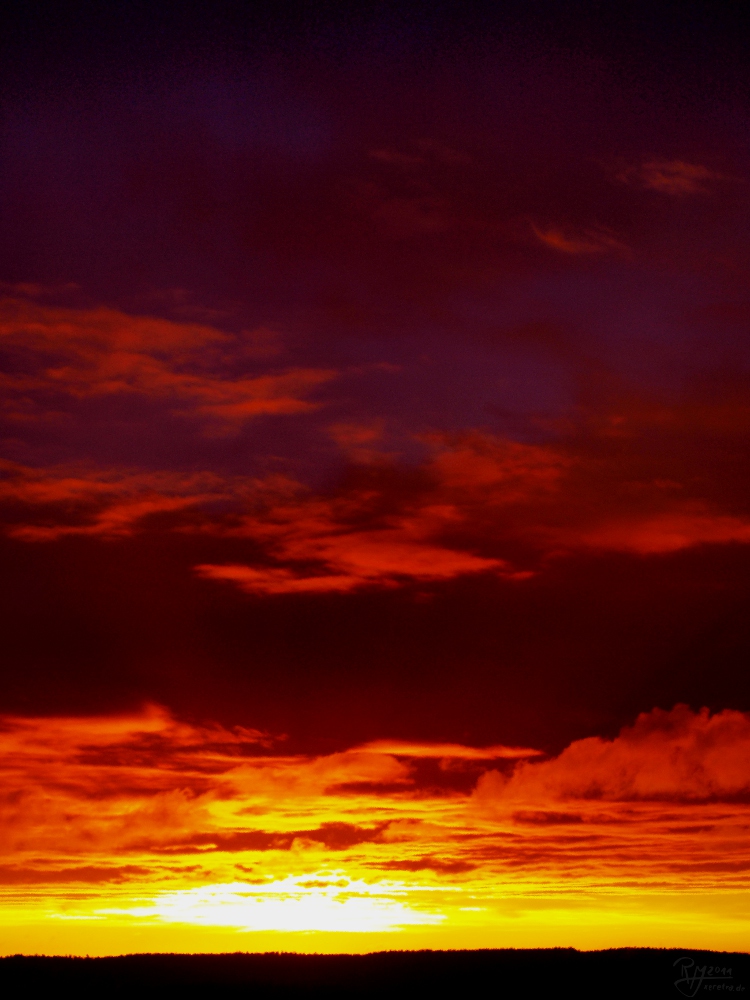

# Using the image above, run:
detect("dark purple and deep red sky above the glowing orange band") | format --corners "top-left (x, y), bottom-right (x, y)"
top-left (0, 3), bottom-right (750, 745)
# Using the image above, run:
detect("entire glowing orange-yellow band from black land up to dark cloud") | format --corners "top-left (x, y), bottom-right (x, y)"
top-left (0, 707), bottom-right (750, 954)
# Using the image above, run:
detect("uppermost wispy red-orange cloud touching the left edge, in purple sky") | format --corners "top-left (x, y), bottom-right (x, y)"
top-left (0, 299), bottom-right (336, 429)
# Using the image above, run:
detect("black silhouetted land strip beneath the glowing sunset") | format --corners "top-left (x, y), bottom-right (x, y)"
top-left (0, 948), bottom-right (750, 1000)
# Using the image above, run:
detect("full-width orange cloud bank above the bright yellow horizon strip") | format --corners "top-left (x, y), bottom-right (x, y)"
top-left (0, 706), bottom-right (750, 907)
